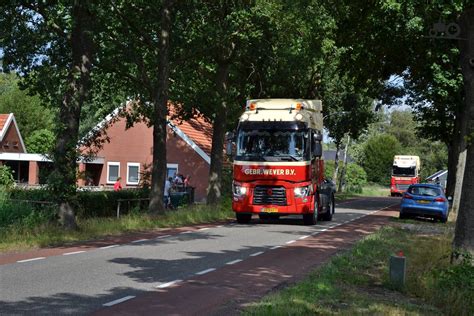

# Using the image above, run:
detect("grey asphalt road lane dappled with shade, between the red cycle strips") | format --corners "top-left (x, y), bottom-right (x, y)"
top-left (0, 198), bottom-right (399, 315)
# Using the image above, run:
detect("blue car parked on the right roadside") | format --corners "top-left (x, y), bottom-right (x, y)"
top-left (400, 183), bottom-right (449, 223)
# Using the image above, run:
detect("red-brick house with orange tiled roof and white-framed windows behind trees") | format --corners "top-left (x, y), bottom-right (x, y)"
top-left (79, 105), bottom-right (212, 201)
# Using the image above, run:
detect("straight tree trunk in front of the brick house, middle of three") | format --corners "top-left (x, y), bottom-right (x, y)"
top-left (148, 0), bottom-right (174, 213)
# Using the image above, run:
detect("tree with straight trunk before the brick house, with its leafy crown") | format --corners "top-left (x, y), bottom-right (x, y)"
top-left (97, 0), bottom-right (175, 213)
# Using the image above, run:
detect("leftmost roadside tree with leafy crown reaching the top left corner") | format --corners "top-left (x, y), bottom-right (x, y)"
top-left (0, 1), bottom-right (94, 229)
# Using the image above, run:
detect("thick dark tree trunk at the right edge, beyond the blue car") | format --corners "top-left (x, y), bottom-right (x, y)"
top-left (453, 8), bottom-right (474, 259)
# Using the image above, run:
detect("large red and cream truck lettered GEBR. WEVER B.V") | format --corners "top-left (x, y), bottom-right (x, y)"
top-left (227, 99), bottom-right (335, 225)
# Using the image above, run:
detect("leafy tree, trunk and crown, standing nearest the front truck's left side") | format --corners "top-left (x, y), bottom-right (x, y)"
top-left (171, 1), bottom-right (269, 204)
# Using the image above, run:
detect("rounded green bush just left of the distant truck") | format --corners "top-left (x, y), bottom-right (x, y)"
top-left (359, 134), bottom-right (403, 185)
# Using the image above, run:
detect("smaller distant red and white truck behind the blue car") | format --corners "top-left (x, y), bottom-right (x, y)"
top-left (390, 155), bottom-right (420, 196)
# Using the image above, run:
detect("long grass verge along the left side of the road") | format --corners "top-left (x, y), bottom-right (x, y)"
top-left (0, 200), bottom-right (233, 252)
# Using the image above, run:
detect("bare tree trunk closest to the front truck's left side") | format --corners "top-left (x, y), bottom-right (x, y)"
top-left (207, 61), bottom-right (229, 205)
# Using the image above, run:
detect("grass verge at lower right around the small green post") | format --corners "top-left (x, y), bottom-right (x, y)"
top-left (244, 223), bottom-right (474, 315)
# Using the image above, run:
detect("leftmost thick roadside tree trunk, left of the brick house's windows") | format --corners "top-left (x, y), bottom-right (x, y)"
top-left (49, 1), bottom-right (93, 229)
